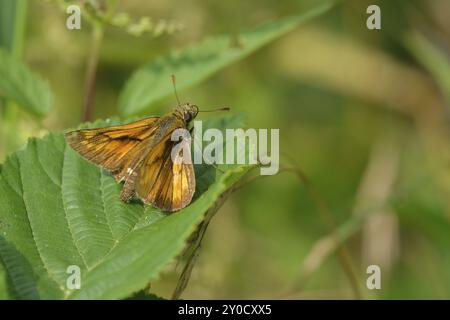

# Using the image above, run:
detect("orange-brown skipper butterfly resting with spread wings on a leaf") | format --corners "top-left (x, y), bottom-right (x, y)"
top-left (65, 104), bottom-right (198, 211)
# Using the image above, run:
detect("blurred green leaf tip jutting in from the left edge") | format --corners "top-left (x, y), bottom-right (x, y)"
top-left (0, 50), bottom-right (52, 115)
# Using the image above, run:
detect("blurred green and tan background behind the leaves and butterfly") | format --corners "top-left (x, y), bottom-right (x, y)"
top-left (0, 0), bottom-right (450, 299)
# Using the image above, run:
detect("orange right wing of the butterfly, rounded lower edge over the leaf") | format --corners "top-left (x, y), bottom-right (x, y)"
top-left (136, 131), bottom-right (195, 211)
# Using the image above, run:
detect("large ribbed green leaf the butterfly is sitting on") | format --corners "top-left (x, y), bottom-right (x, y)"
top-left (0, 116), bottom-right (250, 299)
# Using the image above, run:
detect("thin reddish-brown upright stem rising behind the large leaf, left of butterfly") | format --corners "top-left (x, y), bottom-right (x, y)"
top-left (82, 24), bottom-right (103, 121)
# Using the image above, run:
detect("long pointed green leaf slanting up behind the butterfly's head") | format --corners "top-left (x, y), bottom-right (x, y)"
top-left (119, 2), bottom-right (333, 115)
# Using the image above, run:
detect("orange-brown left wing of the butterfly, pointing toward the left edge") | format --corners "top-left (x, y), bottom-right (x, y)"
top-left (65, 117), bottom-right (159, 180)
